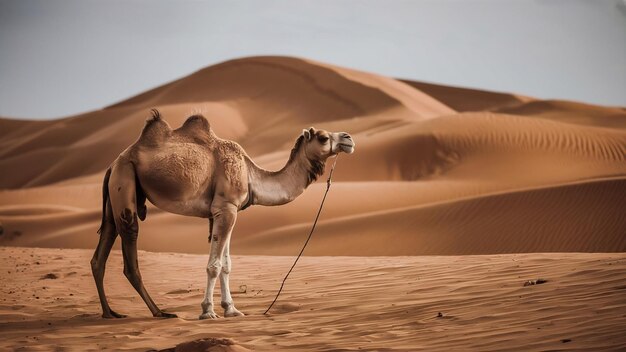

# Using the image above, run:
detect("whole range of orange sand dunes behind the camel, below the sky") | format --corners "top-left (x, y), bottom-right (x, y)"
top-left (0, 57), bottom-right (626, 255)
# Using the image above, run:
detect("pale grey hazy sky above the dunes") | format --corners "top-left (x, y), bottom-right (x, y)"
top-left (0, 0), bottom-right (626, 118)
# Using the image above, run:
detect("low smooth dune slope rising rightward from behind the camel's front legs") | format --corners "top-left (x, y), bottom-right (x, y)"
top-left (239, 178), bottom-right (626, 256)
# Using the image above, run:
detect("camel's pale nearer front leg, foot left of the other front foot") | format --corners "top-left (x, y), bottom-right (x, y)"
top-left (200, 203), bottom-right (237, 319)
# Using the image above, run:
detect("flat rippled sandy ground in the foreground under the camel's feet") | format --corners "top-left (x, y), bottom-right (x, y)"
top-left (0, 247), bottom-right (626, 351)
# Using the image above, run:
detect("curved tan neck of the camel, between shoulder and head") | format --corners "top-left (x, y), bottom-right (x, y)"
top-left (246, 147), bottom-right (324, 205)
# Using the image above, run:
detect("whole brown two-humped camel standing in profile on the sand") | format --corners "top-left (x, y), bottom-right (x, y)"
top-left (91, 109), bottom-right (355, 319)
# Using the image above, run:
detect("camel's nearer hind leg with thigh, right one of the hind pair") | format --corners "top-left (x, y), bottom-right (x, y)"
top-left (109, 157), bottom-right (176, 318)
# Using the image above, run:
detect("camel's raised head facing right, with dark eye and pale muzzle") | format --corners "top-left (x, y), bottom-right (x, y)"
top-left (302, 127), bottom-right (355, 161)
